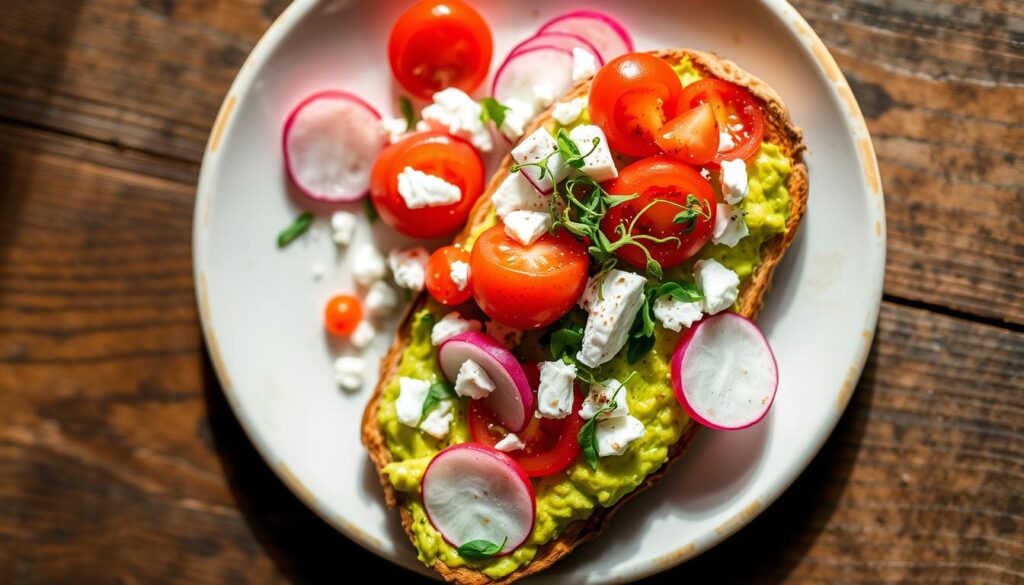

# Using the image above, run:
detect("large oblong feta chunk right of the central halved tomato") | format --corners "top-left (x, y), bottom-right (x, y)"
top-left (577, 268), bottom-right (647, 368)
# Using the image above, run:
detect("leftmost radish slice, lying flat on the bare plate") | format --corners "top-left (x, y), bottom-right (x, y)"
top-left (282, 90), bottom-right (384, 203)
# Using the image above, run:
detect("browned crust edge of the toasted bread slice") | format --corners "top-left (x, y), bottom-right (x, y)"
top-left (362, 49), bottom-right (808, 585)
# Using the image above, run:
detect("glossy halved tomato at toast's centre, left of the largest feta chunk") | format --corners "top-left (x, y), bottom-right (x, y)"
top-left (469, 223), bottom-right (589, 329)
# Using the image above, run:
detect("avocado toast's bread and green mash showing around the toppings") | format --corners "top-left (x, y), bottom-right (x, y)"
top-left (362, 49), bottom-right (808, 584)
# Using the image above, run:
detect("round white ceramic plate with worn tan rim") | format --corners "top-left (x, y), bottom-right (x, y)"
top-left (195, 0), bottom-right (885, 583)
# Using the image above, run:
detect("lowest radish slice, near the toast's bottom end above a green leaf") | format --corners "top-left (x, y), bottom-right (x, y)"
top-left (423, 443), bottom-right (537, 556)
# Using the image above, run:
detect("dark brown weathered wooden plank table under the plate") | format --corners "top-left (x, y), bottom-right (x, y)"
top-left (0, 0), bottom-right (1024, 584)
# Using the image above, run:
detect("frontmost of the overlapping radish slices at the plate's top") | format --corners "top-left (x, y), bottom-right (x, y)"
top-left (490, 45), bottom-right (572, 109)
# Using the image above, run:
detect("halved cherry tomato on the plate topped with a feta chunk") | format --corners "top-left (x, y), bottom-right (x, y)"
top-left (370, 132), bottom-right (484, 238)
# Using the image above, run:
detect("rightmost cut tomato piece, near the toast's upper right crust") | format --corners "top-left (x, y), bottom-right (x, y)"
top-left (678, 79), bottom-right (765, 163)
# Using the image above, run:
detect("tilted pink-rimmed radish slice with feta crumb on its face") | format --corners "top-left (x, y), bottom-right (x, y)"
top-left (437, 331), bottom-right (534, 432)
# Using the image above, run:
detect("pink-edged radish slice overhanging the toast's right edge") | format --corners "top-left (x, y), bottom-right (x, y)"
top-left (672, 312), bottom-right (778, 430)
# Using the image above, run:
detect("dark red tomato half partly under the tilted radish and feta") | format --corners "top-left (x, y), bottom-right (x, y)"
top-left (468, 364), bottom-right (585, 477)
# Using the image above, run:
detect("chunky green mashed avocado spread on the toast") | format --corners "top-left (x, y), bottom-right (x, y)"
top-left (378, 60), bottom-right (791, 579)
